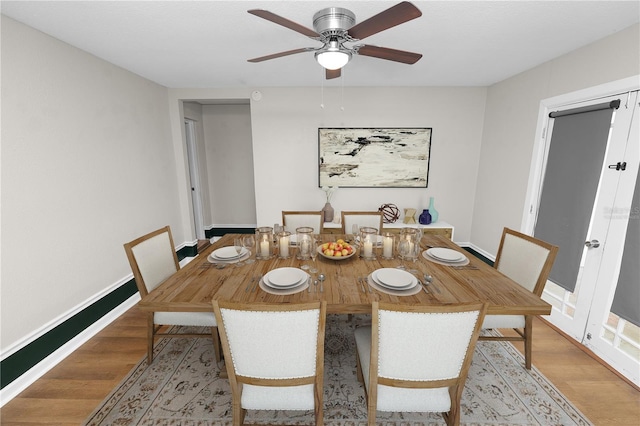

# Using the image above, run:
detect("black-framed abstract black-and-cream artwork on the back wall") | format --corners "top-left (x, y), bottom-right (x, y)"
top-left (318, 127), bottom-right (431, 188)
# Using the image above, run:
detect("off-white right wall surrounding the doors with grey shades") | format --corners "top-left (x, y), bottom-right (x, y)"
top-left (472, 25), bottom-right (640, 255)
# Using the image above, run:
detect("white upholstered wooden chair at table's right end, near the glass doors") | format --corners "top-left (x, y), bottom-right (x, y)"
top-left (480, 228), bottom-right (558, 370)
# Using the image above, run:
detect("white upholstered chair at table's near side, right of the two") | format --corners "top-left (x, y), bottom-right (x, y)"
top-left (355, 301), bottom-right (486, 426)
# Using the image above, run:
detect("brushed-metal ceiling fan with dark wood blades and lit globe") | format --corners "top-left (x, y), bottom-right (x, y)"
top-left (248, 1), bottom-right (422, 79)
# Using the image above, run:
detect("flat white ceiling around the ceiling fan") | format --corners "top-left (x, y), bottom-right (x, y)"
top-left (1, 0), bottom-right (640, 88)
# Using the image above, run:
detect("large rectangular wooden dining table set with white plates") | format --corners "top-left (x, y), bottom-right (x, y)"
top-left (139, 234), bottom-right (551, 315)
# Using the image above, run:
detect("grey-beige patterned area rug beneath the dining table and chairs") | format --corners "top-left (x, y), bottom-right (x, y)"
top-left (84, 315), bottom-right (591, 426)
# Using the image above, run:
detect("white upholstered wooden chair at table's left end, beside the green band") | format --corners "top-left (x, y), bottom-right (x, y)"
top-left (124, 226), bottom-right (221, 364)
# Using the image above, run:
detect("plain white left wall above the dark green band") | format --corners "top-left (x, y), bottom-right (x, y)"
top-left (1, 16), bottom-right (182, 352)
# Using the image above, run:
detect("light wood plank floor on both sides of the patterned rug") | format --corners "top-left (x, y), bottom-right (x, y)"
top-left (0, 307), bottom-right (640, 426)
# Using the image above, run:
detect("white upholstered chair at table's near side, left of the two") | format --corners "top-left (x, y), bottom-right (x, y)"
top-left (213, 300), bottom-right (327, 425)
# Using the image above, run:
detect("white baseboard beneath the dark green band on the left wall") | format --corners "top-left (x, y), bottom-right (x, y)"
top-left (0, 293), bottom-right (140, 407)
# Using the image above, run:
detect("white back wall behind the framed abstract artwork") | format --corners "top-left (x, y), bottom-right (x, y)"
top-left (251, 87), bottom-right (486, 242)
